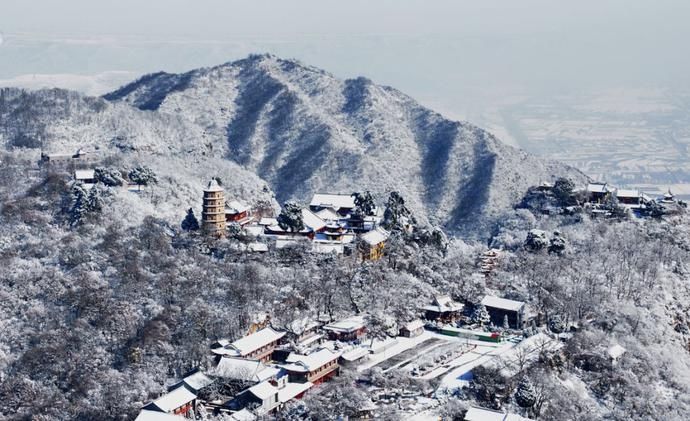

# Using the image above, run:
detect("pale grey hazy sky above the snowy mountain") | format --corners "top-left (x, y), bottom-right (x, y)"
top-left (0, 0), bottom-right (690, 112)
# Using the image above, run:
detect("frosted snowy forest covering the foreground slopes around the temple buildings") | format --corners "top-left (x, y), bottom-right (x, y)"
top-left (0, 153), bottom-right (690, 420)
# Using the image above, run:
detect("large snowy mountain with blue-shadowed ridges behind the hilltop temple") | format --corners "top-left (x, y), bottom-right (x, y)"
top-left (105, 55), bottom-right (584, 233)
